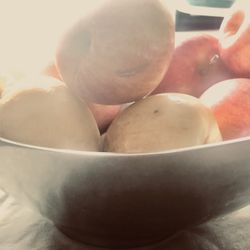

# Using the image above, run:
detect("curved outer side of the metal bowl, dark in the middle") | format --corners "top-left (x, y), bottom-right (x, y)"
top-left (0, 139), bottom-right (250, 249)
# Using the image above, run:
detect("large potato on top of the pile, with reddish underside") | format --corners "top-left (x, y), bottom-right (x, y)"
top-left (56, 0), bottom-right (175, 104)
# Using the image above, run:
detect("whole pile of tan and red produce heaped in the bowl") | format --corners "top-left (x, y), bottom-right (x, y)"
top-left (0, 0), bottom-right (250, 153)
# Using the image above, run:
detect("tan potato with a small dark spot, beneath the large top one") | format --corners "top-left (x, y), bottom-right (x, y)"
top-left (104, 93), bottom-right (222, 153)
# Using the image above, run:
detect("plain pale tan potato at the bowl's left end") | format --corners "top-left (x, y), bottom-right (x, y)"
top-left (0, 77), bottom-right (100, 151)
